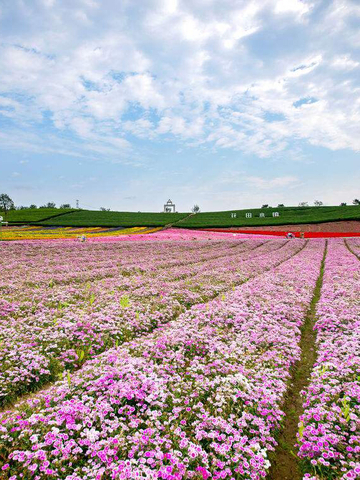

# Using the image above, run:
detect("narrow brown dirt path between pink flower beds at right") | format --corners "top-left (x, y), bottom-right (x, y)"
top-left (267, 241), bottom-right (328, 480)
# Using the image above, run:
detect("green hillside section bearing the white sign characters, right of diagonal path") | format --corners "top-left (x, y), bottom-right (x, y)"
top-left (179, 205), bottom-right (360, 228)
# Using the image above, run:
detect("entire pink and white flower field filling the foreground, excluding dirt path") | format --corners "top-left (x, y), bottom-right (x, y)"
top-left (0, 229), bottom-right (360, 480)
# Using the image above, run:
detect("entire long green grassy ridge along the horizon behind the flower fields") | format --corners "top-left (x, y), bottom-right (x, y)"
top-left (0, 205), bottom-right (360, 228)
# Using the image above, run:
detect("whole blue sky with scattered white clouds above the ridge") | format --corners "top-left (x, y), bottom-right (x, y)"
top-left (0, 0), bottom-right (360, 211)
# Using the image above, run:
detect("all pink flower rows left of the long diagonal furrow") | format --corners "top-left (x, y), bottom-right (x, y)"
top-left (0, 240), bottom-right (304, 404)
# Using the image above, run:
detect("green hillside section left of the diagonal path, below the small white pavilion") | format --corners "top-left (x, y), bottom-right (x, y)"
top-left (40, 210), bottom-right (188, 227)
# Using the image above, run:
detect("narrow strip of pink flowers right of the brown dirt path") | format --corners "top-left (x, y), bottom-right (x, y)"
top-left (298, 240), bottom-right (360, 479)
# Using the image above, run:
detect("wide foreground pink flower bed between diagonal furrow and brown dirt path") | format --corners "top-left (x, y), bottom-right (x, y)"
top-left (0, 241), bottom-right (324, 480)
